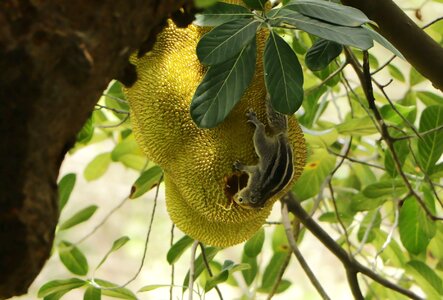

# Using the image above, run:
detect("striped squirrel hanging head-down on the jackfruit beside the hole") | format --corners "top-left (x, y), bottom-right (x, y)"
top-left (233, 94), bottom-right (294, 209)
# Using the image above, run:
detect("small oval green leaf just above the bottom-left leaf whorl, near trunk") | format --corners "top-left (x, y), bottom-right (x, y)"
top-left (58, 241), bottom-right (89, 275)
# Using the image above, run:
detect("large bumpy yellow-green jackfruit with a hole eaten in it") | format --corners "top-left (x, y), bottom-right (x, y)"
top-left (125, 10), bottom-right (306, 247)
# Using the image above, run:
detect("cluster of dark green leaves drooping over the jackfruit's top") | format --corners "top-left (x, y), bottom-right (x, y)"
top-left (191, 0), bottom-right (401, 128)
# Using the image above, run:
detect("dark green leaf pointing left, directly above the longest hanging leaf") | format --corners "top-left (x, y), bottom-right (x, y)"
top-left (197, 19), bottom-right (261, 65)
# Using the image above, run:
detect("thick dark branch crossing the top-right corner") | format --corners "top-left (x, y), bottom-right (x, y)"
top-left (342, 0), bottom-right (443, 91)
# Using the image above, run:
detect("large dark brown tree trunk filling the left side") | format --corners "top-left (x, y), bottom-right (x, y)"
top-left (0, 0), bottom-right (186, 299)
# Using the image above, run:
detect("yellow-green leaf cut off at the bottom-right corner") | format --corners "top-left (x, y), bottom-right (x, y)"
top-left (406, 260), bottom-right (443, 299)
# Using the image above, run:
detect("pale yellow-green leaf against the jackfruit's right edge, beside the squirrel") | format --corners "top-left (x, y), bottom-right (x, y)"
top-left (292, 149), bottom-right (336, 200)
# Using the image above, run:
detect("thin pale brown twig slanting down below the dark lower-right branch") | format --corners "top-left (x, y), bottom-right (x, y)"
top-left (282, 203), bottom-right (331, 299)
